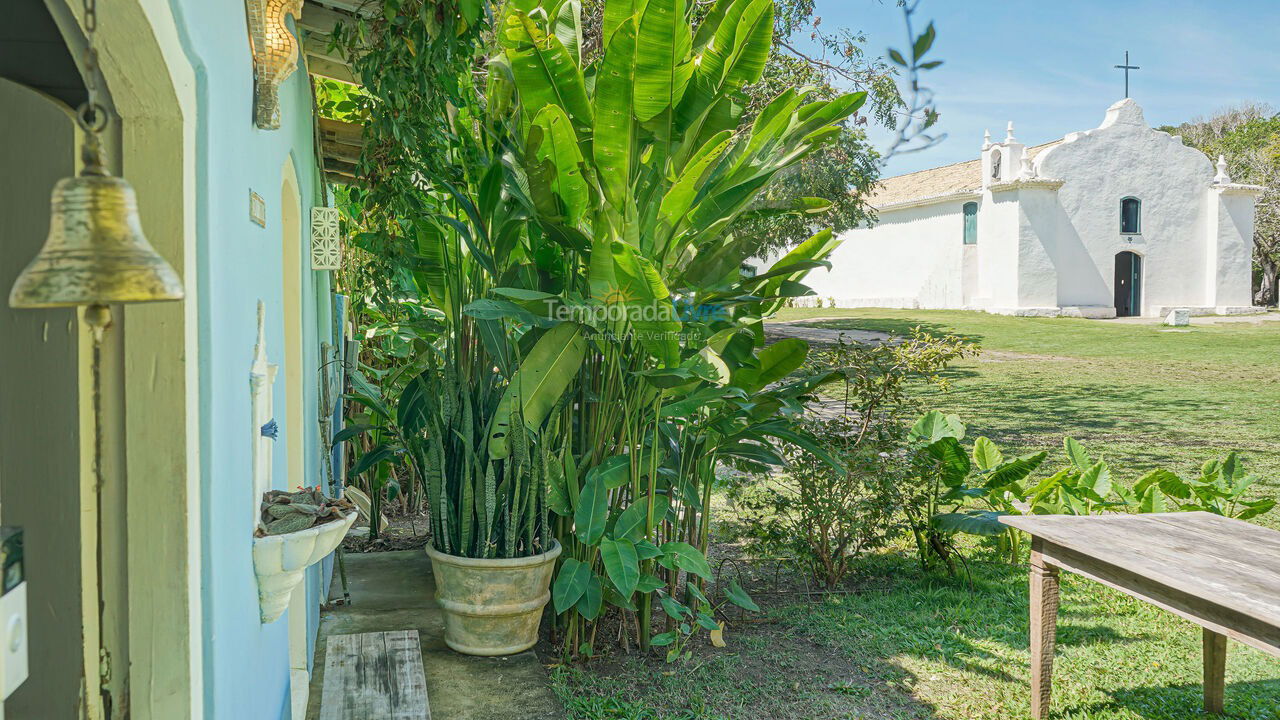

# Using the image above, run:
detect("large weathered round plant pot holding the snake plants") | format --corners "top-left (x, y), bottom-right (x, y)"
top-left (426, 542), bottom-right (561, 655)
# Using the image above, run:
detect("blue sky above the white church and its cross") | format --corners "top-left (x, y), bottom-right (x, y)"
top-left (817, 0), bottom-right (1280, 176)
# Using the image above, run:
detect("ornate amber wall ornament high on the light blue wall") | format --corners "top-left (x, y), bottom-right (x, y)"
top-left (244, 0), bottom-right (302, 129)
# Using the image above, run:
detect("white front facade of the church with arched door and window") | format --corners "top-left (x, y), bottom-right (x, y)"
top-left (1037, 100), bottom-right (1215, 315)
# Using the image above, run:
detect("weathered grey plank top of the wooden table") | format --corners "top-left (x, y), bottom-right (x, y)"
top-left (1001, 512), bottom-right (1280, 628)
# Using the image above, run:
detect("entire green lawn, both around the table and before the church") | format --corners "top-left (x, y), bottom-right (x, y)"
top-left (553, 309), bottom-right (1280, 720)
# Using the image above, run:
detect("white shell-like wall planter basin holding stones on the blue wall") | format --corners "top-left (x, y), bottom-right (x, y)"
top-left (253, 510), bottom-right (358, 623)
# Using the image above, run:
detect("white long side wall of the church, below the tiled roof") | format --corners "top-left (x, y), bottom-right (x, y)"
top-left (805, 196), bottom-right (977, 307)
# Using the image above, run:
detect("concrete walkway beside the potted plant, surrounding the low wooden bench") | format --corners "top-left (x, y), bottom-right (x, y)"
top-left (307, 550), bottom-right (564, 720)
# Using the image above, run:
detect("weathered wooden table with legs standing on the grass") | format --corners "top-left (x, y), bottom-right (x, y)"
top-left (1000, 512), bottom-right (1280, 720)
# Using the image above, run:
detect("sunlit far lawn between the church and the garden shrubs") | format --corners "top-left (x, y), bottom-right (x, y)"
top-left (781, 309), bottom-right (1280, 492)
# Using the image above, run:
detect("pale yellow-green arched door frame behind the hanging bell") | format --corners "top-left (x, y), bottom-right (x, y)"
top-left (45, 0), bottom-right (204, 720)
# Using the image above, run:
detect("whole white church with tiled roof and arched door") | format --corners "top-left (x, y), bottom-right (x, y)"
top-left (805, 99), bottom-right (1263, 318)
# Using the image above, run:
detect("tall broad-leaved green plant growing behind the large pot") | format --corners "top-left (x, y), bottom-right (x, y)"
top-left (483, 0), bottom-right (885, 656)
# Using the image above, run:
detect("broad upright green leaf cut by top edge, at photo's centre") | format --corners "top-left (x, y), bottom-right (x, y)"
top-left (635, 0), bottom-right (694, 122)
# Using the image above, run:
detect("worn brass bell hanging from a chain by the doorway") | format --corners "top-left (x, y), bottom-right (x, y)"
top-left (9, 131), bottom-right (184, 307)
